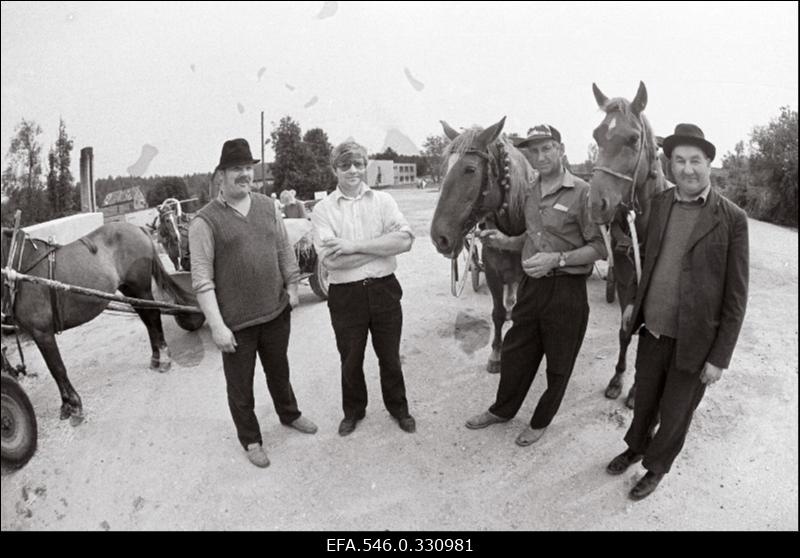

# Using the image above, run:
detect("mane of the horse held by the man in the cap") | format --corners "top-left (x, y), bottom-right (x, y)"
top-left (441, 126), bottom-right (533, 232)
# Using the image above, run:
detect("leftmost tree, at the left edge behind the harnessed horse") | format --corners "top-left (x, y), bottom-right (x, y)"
top-left (0, 118), bottom-right (50, 226)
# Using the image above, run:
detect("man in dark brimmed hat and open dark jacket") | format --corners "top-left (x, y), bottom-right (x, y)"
top-left (607, 124), bottom-right (749, 500)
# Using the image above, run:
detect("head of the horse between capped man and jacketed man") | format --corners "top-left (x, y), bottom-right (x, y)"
top-left (589, 82), bottom-right (660, 224)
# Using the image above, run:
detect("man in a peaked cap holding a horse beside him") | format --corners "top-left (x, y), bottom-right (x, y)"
top-left (466, 124), bottom-right (606, 446)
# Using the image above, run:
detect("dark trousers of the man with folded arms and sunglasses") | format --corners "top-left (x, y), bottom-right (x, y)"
top-left (328, 274), bottom-right (408, 419)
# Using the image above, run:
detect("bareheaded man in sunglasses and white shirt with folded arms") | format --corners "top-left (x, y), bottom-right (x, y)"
top-left (311, 141), bottom-right (416, 436)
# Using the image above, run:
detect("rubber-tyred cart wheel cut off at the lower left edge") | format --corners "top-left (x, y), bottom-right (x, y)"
top-left (2, 374), bottom-right (38, 467)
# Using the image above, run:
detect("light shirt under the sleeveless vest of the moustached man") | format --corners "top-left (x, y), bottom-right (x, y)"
top-left (189, 192), bottom-right (300, 294)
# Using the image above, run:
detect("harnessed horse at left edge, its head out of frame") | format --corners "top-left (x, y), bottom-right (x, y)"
top-left (2, 223), bottom-right (202, 425)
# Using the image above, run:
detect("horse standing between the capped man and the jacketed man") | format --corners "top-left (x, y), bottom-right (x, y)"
top-left (589, 82), bottom-right (672, 409)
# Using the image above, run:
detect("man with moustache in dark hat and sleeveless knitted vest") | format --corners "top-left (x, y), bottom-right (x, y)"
top-left (189, 139), bottom-right (317, 467)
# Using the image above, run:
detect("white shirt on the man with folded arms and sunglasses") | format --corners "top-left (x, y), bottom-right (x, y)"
top-left (311, 182), bottom-right (414, 284)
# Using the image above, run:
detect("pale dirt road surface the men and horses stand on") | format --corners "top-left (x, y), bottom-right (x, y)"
top-left (2, 190), bottom-right (798, 530)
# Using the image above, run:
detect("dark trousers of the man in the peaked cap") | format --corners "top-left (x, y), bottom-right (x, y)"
top-left (489, 275), bottom-right (589, 428)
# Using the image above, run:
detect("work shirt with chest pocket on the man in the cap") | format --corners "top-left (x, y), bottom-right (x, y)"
top-left (522, 170), bottom-right (607, 275)
